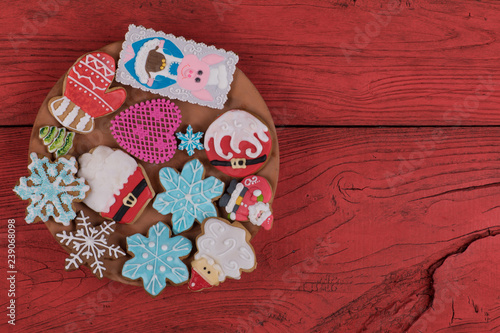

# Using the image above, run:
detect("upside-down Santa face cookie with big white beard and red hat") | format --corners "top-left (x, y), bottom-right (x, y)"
top-left (189, 218), bottom-right (256, 291)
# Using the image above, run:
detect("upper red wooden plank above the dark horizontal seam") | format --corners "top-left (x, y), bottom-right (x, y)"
top-left (0, 0), bottom-right (500, 126)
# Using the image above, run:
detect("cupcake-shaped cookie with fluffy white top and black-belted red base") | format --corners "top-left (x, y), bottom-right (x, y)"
top-left (78, 146), bottom-right (154, 223)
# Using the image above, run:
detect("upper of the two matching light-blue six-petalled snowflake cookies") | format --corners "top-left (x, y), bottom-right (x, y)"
top-left (153, 159), bottom-right (224, 234)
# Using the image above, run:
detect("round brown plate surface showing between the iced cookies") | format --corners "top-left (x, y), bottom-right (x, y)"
top-left (29, 42), bottom-right (279, 286)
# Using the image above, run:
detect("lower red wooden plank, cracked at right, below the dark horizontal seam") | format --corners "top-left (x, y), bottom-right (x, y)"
top-left (0, 128), bottom-right (500, 332)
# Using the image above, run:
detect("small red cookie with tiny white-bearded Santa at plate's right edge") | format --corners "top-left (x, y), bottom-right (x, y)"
top-left (219, 175), bottom-right (274, 230)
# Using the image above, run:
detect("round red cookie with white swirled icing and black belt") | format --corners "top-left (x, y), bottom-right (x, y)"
top-left (204, 110), bottom-right (272, 178)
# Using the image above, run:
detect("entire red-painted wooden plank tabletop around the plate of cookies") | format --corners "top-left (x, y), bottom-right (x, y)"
top-left (0, 0), bottom-right (500, 332)
